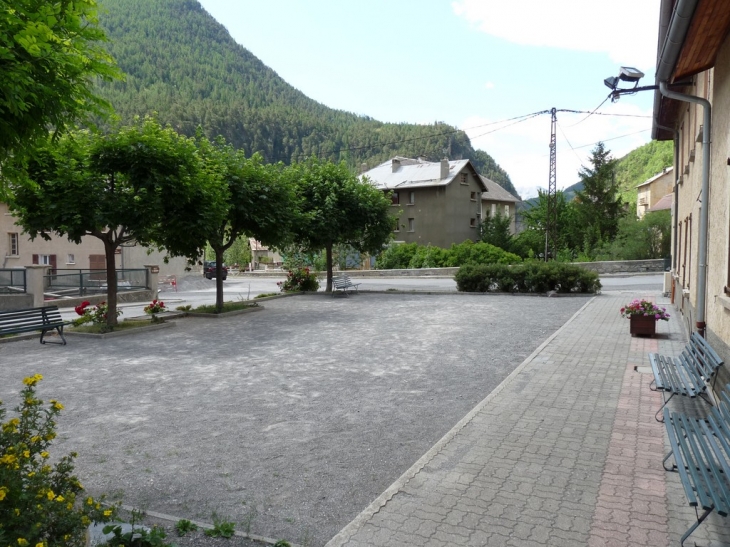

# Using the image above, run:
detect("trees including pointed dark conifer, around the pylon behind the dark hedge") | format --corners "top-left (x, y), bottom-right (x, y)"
top-left (481, 143), bottom-right (671, 261)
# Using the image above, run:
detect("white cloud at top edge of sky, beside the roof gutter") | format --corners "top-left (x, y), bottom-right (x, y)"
top-left (452, 0), bottom-right (659, 71)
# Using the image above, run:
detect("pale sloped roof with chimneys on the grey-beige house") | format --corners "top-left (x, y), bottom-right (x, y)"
top-left (362, 156), bottom-right (484, 190)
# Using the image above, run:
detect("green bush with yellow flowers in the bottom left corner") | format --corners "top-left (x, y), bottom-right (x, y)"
top-left (0, 374), bottom-right (117, 547)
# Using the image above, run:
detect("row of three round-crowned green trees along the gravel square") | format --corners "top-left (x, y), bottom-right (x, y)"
top-left (5, 118), bottom-right (393, 326)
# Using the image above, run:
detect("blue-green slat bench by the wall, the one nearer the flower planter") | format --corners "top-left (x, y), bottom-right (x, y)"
top-left (649, 332), bottom-right (723, 421)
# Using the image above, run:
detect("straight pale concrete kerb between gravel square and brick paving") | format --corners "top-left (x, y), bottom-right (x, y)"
top-left (325, 293), bottom-right (596, 547)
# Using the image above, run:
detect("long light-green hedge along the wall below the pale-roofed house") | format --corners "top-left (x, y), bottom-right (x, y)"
top-left (375, 240), bottom-right (522, 270)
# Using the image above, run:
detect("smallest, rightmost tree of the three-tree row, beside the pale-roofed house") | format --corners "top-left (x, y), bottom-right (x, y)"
top-left (290, 158), bottom-right (395, 292)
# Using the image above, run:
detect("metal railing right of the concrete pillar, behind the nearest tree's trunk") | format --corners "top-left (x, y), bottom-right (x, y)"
top-left (43, 268), bottom-right (149, 298)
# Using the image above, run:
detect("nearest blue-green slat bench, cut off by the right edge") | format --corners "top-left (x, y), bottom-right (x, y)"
top-left (662, 385), bottom-right (730, 545)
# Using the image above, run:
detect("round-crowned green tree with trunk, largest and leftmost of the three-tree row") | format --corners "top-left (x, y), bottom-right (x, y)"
top-left (10, 119), bottom-right (201, 327)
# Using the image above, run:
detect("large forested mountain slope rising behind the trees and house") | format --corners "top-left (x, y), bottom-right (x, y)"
top-left (98, 0), bottom-right (517, 195)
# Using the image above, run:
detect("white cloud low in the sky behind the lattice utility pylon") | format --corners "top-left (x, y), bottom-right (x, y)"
top-left (461, 103), bottom-right (651, 198)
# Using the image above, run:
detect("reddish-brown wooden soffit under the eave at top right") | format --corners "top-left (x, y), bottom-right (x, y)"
top-left (673, 0), bottom-right (730, 82)
